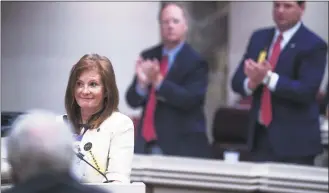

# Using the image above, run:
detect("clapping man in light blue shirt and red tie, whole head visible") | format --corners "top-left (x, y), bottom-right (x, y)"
top-left (126, 3), bottom-right (210, 157)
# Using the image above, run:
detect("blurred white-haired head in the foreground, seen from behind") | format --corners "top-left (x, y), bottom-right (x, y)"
top-left (7, 110), bottom-right (74, 182)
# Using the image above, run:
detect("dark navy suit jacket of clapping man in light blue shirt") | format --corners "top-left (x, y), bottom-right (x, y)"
top-left (126, 43), bottom-right (208, 156)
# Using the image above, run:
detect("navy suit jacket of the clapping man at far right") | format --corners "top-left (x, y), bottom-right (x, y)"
top-left (232, 25), bottom-right (327, 156)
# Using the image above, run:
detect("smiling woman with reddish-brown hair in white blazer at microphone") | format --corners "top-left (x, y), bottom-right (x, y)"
top-left (65, 54), bottom-right (134, 183)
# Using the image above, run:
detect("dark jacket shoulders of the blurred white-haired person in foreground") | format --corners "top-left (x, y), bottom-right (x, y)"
top-left (4, 174), bottom-right (105, 193)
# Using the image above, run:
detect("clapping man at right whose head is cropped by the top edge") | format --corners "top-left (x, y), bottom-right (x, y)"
top-left (232, 1), bottom-right (327, 165)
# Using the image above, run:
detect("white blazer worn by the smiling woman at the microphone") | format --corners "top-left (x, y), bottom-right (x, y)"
top-left (57, 112), bottom-right (134, 183)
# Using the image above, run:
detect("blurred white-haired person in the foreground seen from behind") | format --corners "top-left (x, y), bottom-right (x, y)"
top-left (5, 110), bottom-right (103, 193)
